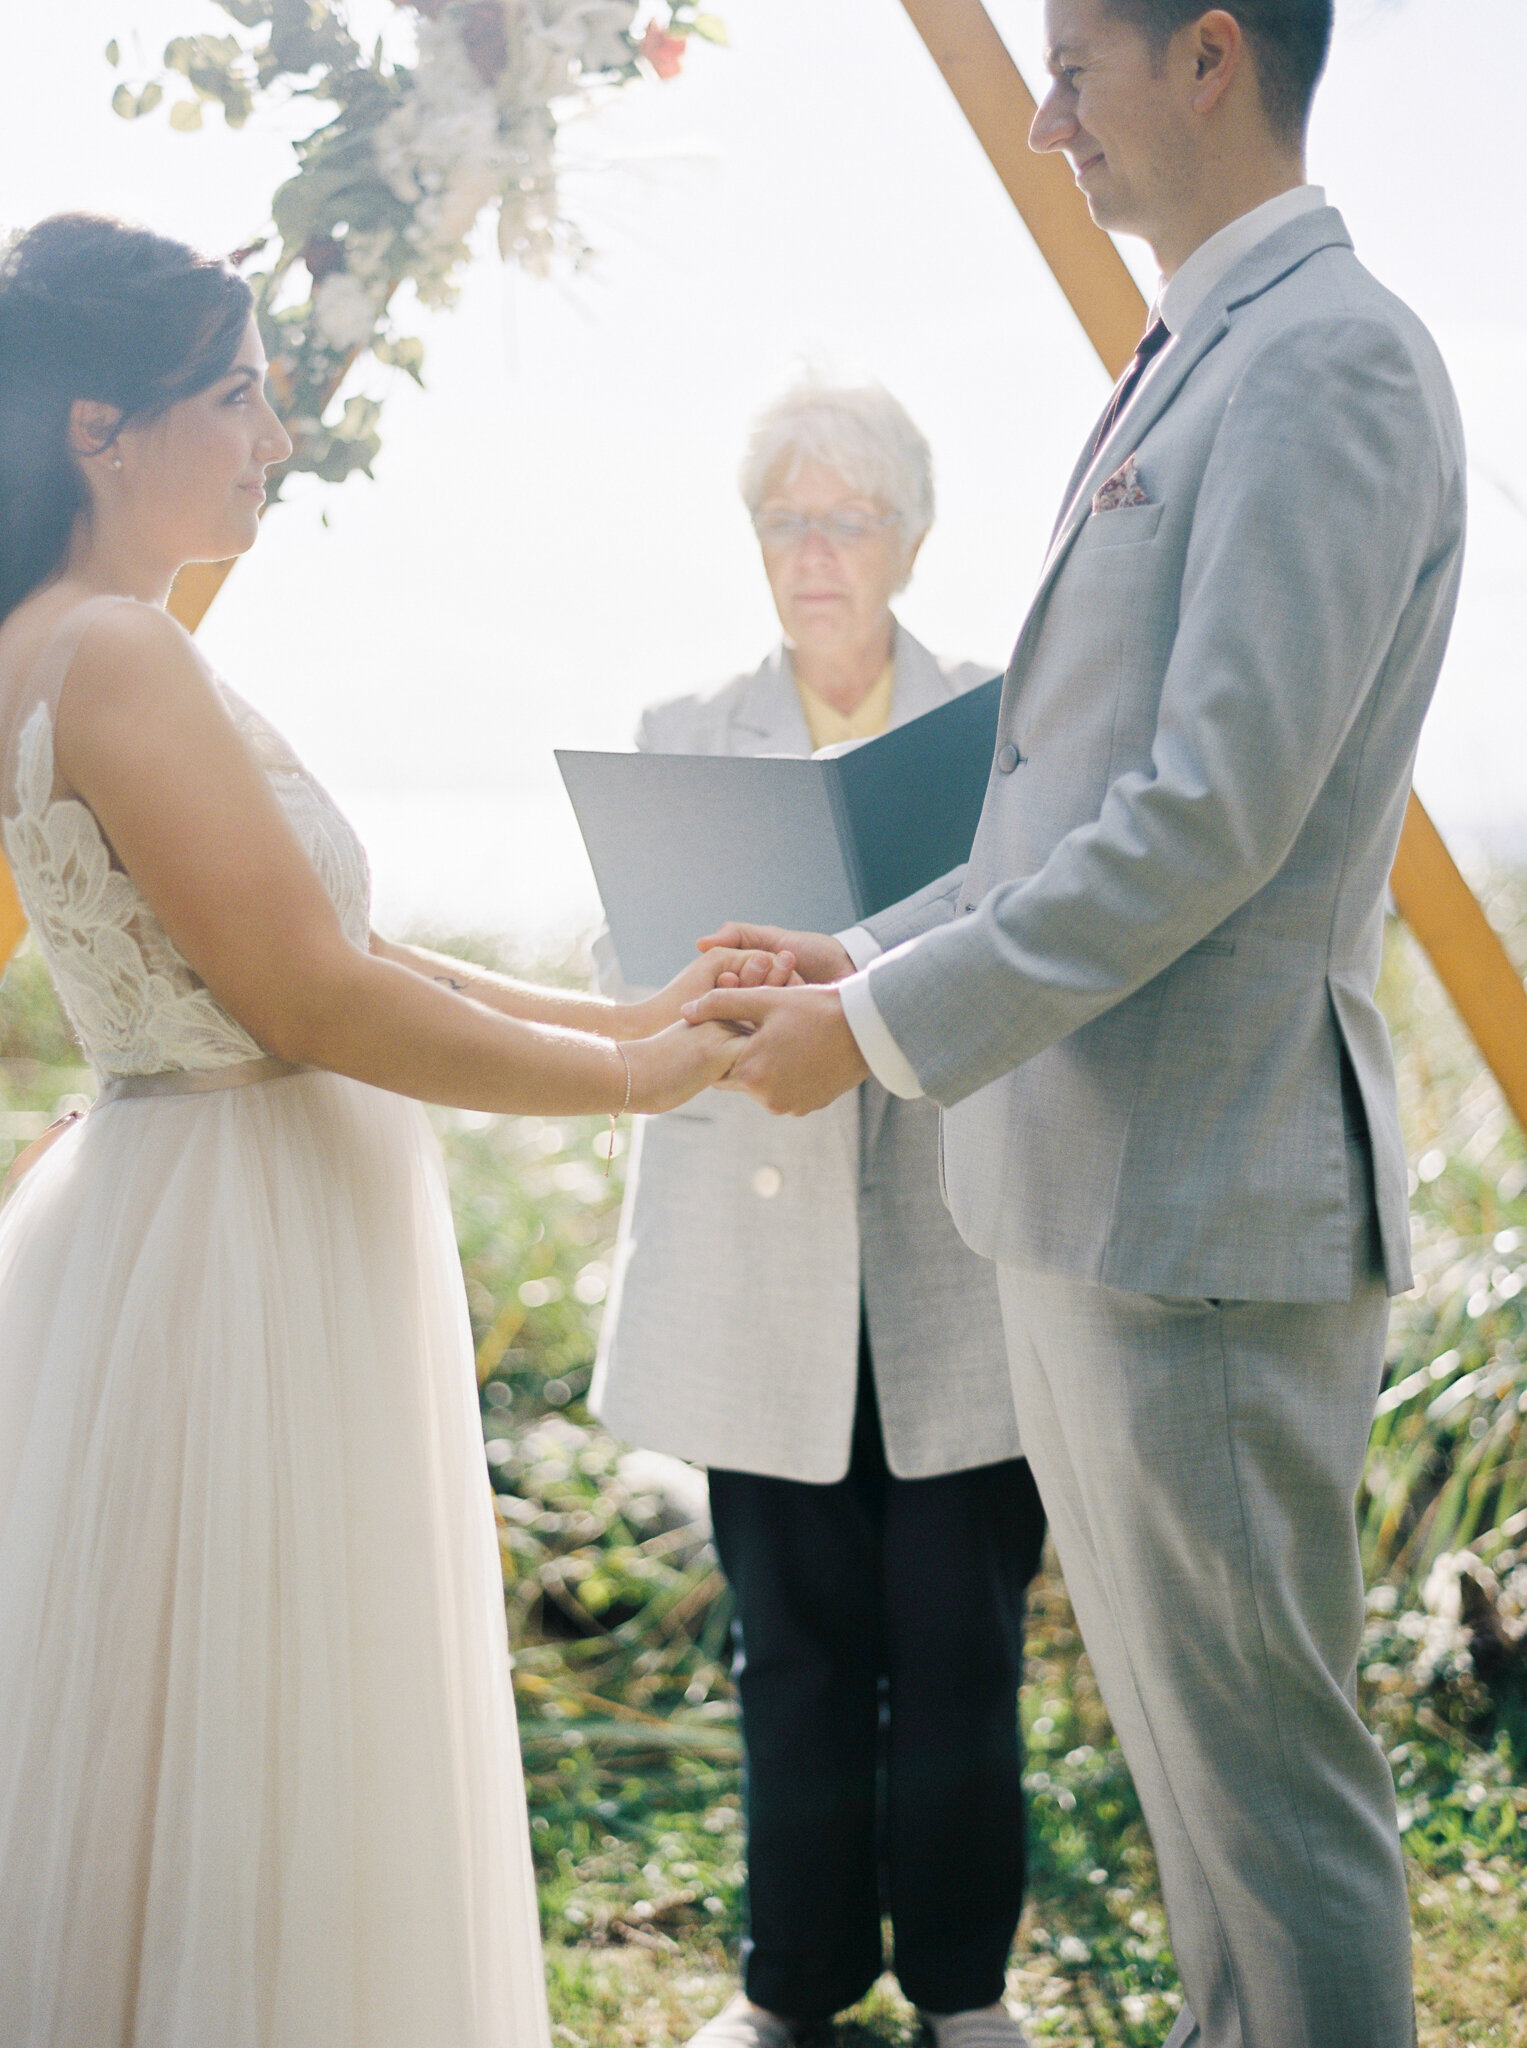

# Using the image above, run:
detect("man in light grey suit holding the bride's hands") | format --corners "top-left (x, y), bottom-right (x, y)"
top-left (692, 0), bottom-right (1464, 2048)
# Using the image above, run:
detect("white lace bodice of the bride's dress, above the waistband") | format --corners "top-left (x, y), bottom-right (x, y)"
top-left (4, 610), bottom-right (370, 1077)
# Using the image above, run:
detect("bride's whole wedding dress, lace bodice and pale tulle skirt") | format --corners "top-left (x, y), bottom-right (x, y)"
top-left (0, 598), bottom-right (549, 2048)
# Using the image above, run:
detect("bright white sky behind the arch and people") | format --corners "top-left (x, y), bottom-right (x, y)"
top-left (0, 0), bottom-right (1527, 936)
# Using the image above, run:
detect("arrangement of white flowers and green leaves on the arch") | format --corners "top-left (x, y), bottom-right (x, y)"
top-left (106, 0), bottom-right (727, 483)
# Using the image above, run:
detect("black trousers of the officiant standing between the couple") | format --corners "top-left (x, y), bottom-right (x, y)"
top-left (710, 1337), bottom-right (1044, 2021)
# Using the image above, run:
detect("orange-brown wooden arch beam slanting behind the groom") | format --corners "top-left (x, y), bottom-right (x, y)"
top-left (903, 0), bottom-right (1527, 1128)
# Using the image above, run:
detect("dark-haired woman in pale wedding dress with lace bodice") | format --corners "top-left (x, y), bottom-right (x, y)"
top-left (0, 215), bottom-right (790, 2048)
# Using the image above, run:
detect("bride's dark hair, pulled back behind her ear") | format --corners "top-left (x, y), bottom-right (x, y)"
top-left (0, 213), bottom-right (254, 621)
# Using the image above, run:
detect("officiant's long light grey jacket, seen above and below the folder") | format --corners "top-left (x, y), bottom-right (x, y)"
top-left (590, 629), bottom-right (1017, 1481)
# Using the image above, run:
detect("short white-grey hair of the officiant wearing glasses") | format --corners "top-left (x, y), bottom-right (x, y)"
top-left (737, 377), bottom-right (933, 551)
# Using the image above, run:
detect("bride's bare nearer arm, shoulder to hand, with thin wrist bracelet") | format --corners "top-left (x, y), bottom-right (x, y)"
top-left (55, 606), bottom-right (737, 1114)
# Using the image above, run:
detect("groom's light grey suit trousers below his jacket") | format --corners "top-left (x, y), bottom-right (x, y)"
top-left (999, 1141), bottom-right (1414, 2048)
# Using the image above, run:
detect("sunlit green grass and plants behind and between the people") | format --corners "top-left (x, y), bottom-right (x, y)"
top-left (0, 905), bottom-right (1527, 2048)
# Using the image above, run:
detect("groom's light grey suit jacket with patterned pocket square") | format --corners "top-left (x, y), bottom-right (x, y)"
top-left (868, 209), bottom-right (1464, 1300)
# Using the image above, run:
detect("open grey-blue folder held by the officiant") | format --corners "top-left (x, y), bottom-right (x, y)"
top-left (557, 676), bottom-right (1003, 987)
